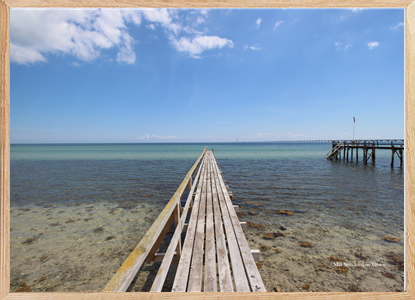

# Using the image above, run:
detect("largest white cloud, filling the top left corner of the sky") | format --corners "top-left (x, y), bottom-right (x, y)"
top-left (10, 9), bottom-right (141, 65)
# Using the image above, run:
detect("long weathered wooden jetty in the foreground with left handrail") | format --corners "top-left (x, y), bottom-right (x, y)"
top-left (103, 148), bottom-right (266, 292)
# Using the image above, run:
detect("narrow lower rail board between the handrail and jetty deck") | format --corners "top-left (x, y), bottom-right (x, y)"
top-left (150, 160), bottom-right (205, 292)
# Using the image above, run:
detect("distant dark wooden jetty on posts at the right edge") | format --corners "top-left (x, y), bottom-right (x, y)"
top-left (324, 140), bottom-right (405, 167)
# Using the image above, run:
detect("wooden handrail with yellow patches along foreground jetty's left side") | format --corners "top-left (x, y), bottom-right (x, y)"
top-left (102, 147), bottom-right (207, 292)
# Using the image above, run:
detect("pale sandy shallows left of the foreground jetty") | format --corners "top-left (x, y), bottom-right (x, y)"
top-left (10, 203), bottom-right (159, 292)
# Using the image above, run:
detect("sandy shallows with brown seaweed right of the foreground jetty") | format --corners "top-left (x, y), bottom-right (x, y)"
top-left (242, 216), bottom-right (404, 292)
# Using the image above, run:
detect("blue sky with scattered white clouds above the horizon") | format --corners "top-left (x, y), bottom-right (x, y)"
top-left (10, 9), bottom-right (405, 143)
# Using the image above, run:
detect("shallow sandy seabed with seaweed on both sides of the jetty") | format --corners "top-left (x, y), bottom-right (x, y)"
top-left (10, 199), bottom-right (404, 292)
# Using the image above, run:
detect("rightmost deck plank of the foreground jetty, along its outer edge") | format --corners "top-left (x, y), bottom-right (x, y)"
top-left (215, 159), bottom-right (266, 292)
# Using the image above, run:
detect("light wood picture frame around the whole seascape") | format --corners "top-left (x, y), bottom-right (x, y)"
top-left (0, 0), bottom-right (415, 300)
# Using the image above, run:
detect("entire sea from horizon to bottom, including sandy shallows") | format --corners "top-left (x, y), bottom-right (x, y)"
top-left (10, 142), bottom-right (405, 292)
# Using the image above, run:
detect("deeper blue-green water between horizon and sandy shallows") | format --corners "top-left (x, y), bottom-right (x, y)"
top-left (11, 143), bottom-right (404, 226)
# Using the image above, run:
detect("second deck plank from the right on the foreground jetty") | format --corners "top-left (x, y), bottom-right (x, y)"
top-left (214, 160), bottom-right (251, 292)
